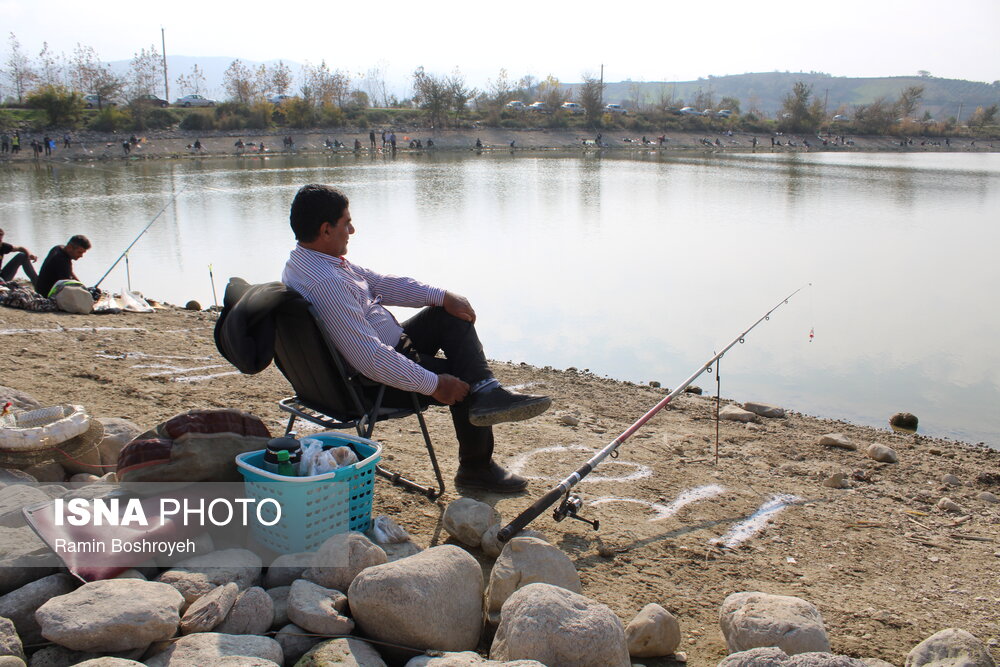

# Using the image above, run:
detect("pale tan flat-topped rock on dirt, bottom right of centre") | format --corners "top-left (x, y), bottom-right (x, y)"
top-left (719, 592), bottom-right (830, 655)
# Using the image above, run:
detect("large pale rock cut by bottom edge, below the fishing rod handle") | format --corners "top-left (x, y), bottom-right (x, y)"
top-left (490, 584), bottom-right (631, 667)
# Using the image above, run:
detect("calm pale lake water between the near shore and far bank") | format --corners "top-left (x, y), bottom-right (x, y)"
top-left (0, 152), bottom-right (1000, 447)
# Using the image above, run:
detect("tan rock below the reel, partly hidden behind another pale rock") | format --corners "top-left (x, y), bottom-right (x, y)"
top-left (486, 537), bottom-right (583, 624)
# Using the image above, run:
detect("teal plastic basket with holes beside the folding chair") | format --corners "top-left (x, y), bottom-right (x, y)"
top-left (236, 432), bottom-right (382, 554)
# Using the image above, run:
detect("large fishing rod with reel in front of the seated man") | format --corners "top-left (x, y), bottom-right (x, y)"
top-left (497, 283), bottom-right (811, 542)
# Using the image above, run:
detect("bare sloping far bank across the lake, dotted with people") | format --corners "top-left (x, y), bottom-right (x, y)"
top-left (0, 127), bottom-right (1000, 162)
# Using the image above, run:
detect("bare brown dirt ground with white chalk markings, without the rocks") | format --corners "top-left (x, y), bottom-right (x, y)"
top-left (0, 308), bottom-right (1000, 666)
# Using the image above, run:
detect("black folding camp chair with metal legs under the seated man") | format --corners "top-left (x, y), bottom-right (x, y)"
top-left (274, 298), bottom-right (444, 500)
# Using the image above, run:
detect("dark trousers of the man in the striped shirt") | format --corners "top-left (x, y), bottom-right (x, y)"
top-left (374, 307), bottom-right (494, 467)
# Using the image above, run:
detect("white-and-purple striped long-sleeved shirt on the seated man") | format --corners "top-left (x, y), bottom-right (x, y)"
top-left (281, 245), bottom-right (445, 396)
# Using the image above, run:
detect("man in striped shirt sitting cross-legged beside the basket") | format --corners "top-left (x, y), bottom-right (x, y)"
top-left (281, 185), bottom-right (552, 493)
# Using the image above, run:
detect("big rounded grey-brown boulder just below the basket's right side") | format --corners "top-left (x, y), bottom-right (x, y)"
top-left (350, 545), bottom-right (483, 651)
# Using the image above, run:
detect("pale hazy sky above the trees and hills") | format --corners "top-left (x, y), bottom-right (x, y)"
top-left (0, 0), bottom-right (1000, 94)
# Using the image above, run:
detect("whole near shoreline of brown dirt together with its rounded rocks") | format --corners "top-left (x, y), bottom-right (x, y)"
top-left (0, 274), bottom-right (1000, 667)
